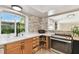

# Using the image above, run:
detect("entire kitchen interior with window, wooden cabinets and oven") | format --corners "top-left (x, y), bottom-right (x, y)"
top-left (0, 5), bottom-right (79, 54)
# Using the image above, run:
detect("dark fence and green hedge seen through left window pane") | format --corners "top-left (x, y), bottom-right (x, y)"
top-left (1, 22), bottom-right (14, 34)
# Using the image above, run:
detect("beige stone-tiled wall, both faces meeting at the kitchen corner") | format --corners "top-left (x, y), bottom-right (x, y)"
top-left (28, 16), bottom-right (48, 32)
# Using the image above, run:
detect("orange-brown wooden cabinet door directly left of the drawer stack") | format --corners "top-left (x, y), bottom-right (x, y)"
top-left (23, 39), bottom-right (32, 54)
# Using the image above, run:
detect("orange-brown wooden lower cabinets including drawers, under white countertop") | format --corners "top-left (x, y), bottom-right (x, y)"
top-left (4, 37), bottom-right (48, 54)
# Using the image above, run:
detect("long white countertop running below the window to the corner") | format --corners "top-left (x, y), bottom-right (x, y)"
top-left (0, 33), bottom-right (51, 45)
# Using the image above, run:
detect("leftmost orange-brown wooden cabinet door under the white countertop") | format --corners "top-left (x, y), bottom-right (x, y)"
top-left (4, 42), bottom-right (22, 54)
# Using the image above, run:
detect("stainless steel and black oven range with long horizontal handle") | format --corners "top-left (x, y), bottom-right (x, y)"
top-left (50, 34), bottom-right (73, 54)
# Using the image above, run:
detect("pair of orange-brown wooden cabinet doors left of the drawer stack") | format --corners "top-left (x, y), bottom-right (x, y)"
top-left (4, 39), bottom-right (32, 54)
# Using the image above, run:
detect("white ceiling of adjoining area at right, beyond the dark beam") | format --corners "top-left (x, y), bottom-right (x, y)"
top-left (49, 11), bottom-right (79, 23)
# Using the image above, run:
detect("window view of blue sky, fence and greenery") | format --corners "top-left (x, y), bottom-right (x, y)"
top-left (0, 12), bottom-right (25, 34)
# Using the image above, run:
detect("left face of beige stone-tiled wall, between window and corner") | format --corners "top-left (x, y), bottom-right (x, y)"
top-left (28, 16), bottom-right (42, 32)
